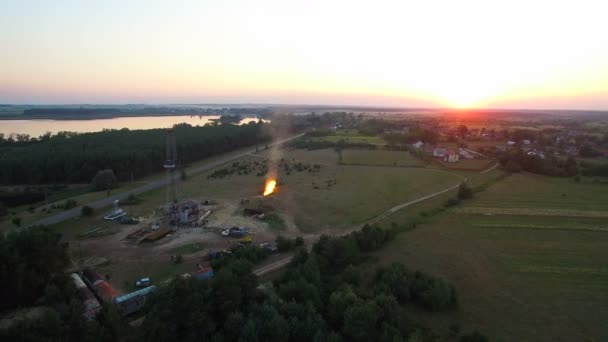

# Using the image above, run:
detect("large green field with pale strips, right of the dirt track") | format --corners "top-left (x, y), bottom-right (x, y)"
top-left (369, 174), bottom-right (608, 341)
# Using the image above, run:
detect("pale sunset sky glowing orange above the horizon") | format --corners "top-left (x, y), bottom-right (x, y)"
top-left (0, 0), bottom-right (608, 110)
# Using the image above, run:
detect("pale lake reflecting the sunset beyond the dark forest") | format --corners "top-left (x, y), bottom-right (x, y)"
top-left (0, 115), bottom-right (258, 137)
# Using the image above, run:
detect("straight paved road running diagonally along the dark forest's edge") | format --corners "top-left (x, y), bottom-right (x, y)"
top-left (29, 133), bottom-right (304, 227)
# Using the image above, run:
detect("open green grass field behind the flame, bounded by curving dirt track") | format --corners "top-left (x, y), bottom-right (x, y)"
top-left (171, 149), bottom-right (462, 233)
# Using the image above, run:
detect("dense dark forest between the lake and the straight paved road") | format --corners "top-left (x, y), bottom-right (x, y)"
top-left (0, 122), bottom-right (269, 184)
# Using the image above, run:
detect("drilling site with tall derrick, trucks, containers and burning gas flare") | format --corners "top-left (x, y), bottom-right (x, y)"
top-left (71, 129), bottom-right (286, 319)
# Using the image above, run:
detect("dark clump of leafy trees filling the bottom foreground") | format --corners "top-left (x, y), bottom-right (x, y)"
top-left (0, 226), bottom-right (476, 341)
